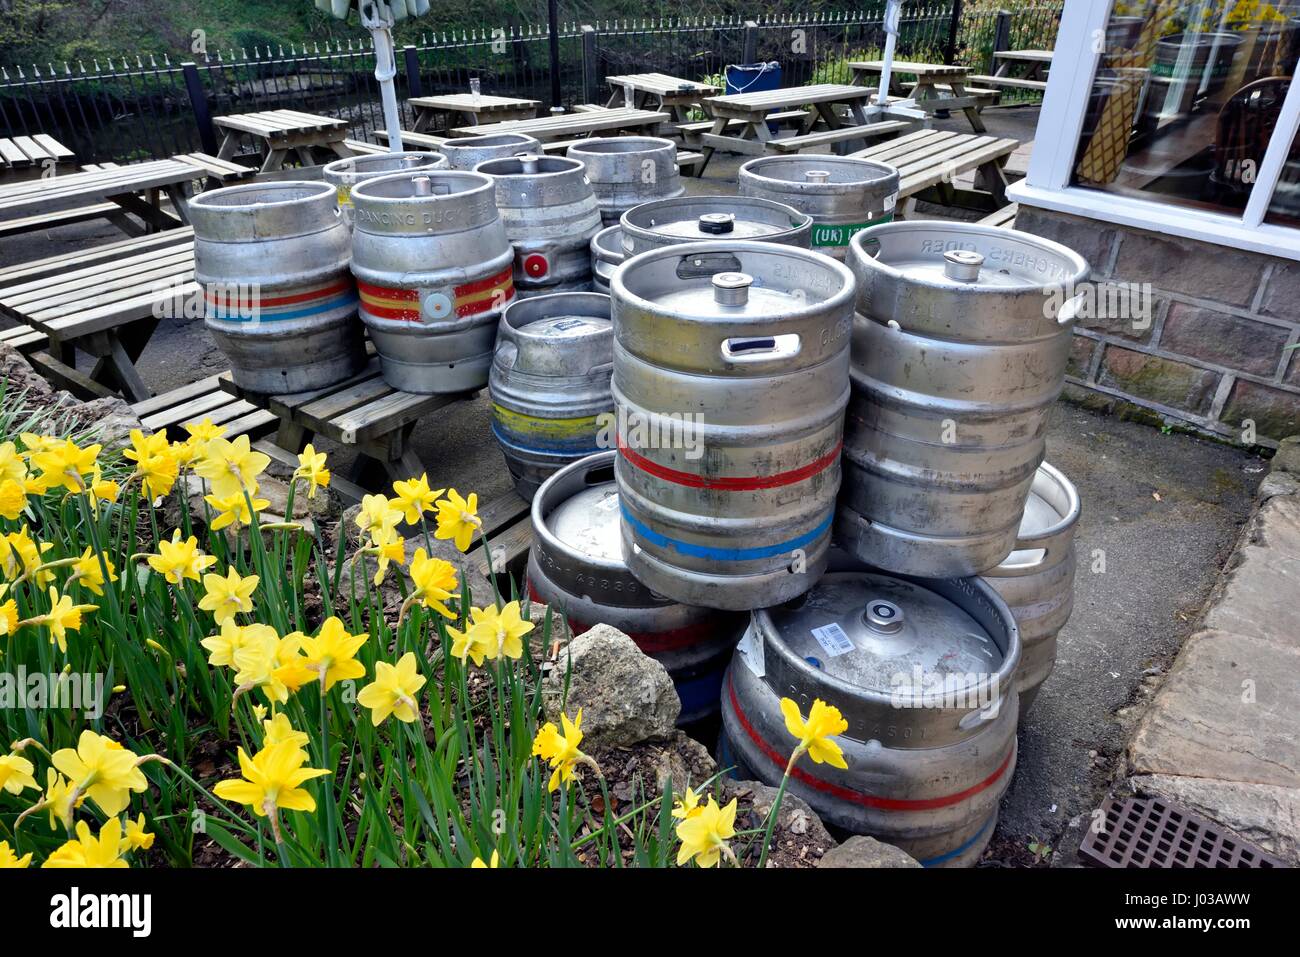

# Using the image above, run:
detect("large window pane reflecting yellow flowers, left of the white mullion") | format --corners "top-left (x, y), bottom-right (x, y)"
top-left (1074, 0), bottom-right (1300, 212)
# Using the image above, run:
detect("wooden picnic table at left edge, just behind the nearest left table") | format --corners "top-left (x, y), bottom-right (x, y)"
top-left (0, 159), bottom-right (204, 235)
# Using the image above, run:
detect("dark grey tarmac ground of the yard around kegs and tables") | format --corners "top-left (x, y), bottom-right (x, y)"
top-left (0, 108), bottom-right (1262, 863)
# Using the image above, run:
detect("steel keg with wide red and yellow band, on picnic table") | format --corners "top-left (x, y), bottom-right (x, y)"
top-left (352, 169), bottom-right (515, 393)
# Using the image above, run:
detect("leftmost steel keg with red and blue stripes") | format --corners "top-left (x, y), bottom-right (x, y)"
top-left (189, 181), bottom-right (365, 395)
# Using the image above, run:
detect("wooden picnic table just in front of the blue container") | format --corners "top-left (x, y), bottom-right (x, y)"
top-left (701, 83), bottom-right (914, 165)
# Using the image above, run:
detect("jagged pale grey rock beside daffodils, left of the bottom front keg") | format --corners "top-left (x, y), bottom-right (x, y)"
top-left (542, 624), bottom-right (681, 748)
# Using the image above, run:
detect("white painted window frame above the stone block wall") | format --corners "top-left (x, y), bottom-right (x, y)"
top-left (1008, 0), bottom-right (1300, 260)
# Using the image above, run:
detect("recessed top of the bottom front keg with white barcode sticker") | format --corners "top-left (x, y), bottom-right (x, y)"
top-left (754, 570), bottom-right (1021, 710)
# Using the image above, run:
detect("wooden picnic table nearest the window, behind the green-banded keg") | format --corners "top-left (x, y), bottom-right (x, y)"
top-left (850, 130), bottom-right (1021, 218)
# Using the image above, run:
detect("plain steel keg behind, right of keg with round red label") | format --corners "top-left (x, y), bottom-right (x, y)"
top-left (566, 137), bottom-right (685, 226)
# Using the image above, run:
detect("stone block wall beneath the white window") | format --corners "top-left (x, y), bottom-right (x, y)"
top-left (1015, 205), bottom-right (1300, 446)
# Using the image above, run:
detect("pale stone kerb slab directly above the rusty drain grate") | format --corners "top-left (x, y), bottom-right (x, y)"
top-left (1130, 774), bottom-right (1300, 863)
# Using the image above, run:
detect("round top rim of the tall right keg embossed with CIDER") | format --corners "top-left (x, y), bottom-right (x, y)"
top-left (849, 220), bottom-right (1089, 289)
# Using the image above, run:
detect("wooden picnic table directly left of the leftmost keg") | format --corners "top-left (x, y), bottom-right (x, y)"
top-left (0, 227), bottom-right (202, 402)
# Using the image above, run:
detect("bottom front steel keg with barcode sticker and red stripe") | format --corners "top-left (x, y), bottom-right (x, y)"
top-left (723, 572), bottom-right (1021, 867)
